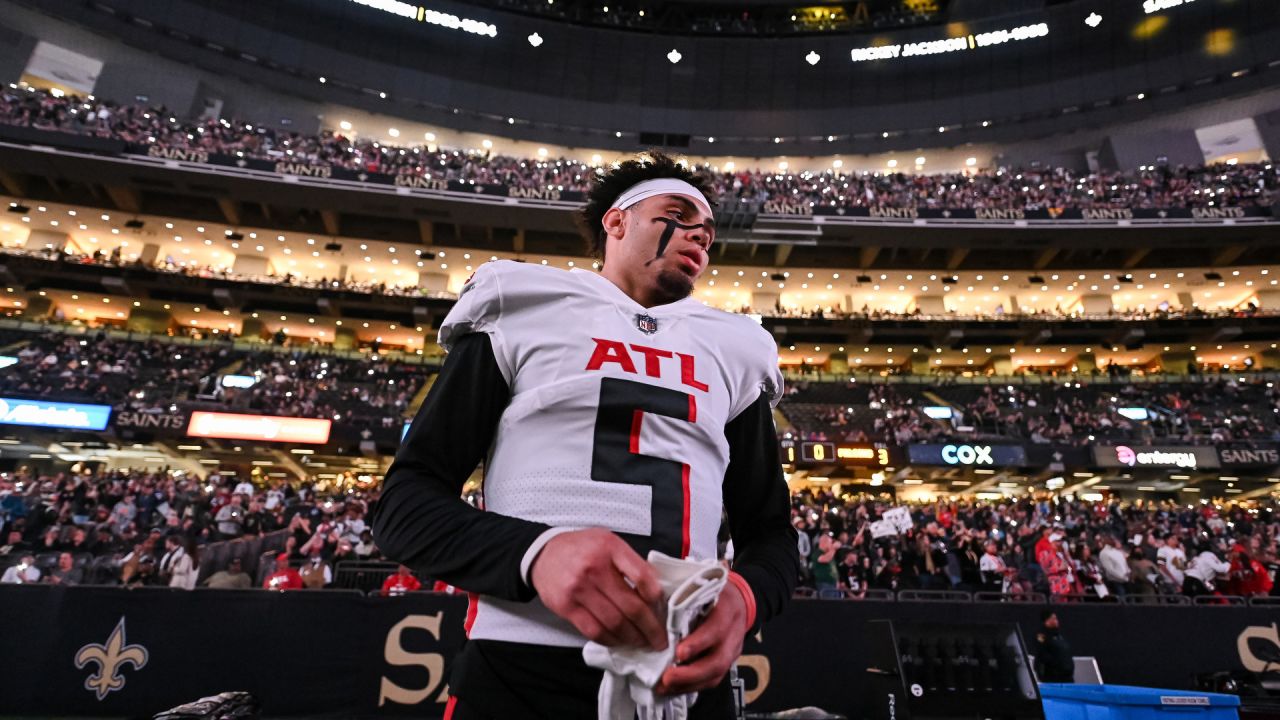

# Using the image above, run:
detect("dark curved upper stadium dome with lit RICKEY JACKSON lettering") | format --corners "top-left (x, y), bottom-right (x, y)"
top-left (20, 0), bottom-right (1280, 156)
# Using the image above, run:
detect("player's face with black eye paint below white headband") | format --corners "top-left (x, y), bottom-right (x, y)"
top-left (605, 195), bottom-right (716, 306)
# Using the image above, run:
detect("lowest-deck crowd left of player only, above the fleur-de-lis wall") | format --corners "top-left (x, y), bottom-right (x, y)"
top-left (0, 468), bottom-right (380, 589)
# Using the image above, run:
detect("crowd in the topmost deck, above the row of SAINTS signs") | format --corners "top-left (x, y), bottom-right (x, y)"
top-left (0, 86), bottom-right (1280, 210)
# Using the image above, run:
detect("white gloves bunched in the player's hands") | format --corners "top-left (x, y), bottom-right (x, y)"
top-left (582, 551), bottom-right (728, 720)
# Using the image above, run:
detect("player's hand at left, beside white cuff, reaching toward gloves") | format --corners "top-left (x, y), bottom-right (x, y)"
top-left (529, 528), bottom-right (667, 650)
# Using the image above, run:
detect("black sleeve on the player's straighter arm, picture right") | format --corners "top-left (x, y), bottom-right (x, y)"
top-left (723, 393), bottom-right (800, 626)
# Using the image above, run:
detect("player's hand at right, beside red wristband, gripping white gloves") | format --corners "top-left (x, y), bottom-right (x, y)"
top-left (653, 583), bottom-right (746, 697)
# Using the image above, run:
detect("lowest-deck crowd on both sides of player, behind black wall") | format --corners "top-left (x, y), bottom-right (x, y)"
top-left (0, 458), bottom-right (1280, 600)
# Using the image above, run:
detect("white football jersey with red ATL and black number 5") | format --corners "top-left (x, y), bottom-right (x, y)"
top-left (440, 260), bottom-right (782, 647)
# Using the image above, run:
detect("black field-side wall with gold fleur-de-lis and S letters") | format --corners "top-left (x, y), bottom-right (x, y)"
top-left (0, 585), bottom-right (1280, 717)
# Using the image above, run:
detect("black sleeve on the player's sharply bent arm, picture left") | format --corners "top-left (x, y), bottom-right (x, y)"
top-left (372, 333), bottom-right (550, 601)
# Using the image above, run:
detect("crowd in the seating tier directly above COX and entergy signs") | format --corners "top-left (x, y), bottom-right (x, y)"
top-left (781, 374), bottom-right (1280, 445)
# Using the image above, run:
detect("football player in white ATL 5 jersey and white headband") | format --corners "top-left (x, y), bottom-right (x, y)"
top-left (374, 152), bottom-right (799, 720)
